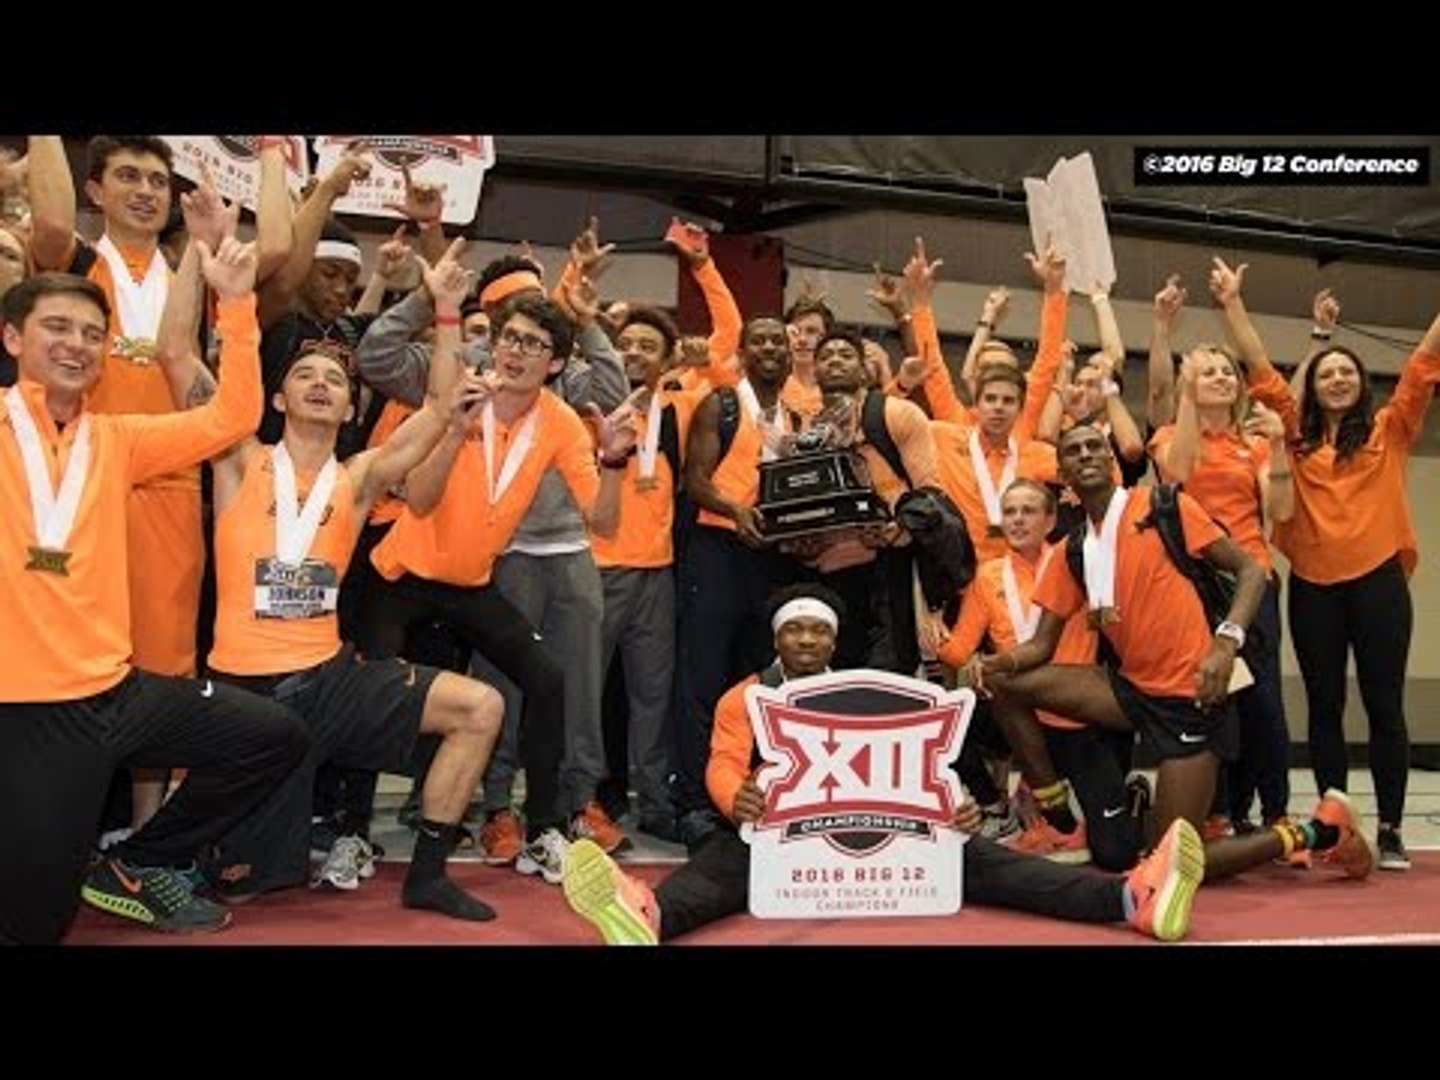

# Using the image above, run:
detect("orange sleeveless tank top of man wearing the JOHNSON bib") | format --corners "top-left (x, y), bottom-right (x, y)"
top-left (209, 446), bottom-right (359, 675)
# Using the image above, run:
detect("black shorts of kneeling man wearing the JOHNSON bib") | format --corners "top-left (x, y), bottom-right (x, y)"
top-left (212, 645), bottom-right (439, 775)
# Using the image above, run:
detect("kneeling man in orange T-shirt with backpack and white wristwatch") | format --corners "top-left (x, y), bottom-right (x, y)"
top-left (966, 423), bottom-right (1375, 878)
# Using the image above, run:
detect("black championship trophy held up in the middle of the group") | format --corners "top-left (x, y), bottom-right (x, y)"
top-left (756, 397), bottom-right (890, 543)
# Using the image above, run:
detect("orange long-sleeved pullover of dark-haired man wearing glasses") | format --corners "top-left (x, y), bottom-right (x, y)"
top-left (370, 390), bottom-right (600, 586)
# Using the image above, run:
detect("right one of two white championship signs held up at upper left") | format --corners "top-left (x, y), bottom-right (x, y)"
top-left (315, 135), bottom-right (495, 225)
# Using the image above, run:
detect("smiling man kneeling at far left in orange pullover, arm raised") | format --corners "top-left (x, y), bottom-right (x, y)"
top-left (0, 249), bottom-right (308, 945)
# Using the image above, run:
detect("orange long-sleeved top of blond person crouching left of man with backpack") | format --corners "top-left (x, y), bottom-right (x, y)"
top-left (939, 544), bottom-right (1099, 729)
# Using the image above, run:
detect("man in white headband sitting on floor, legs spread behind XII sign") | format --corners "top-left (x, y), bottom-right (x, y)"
top-left (563, 585), bottom-right (1205, 945)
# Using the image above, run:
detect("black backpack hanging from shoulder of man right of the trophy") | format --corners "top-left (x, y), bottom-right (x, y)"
top-left (860, 390), bottom-right (976, 611)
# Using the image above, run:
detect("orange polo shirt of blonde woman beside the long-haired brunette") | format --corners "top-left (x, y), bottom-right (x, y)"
top-left (1151, 423), bottom-right (1270, 573)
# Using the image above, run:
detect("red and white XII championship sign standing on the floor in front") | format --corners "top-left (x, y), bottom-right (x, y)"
top-left (740, 670), bottom-right (975, 919)
